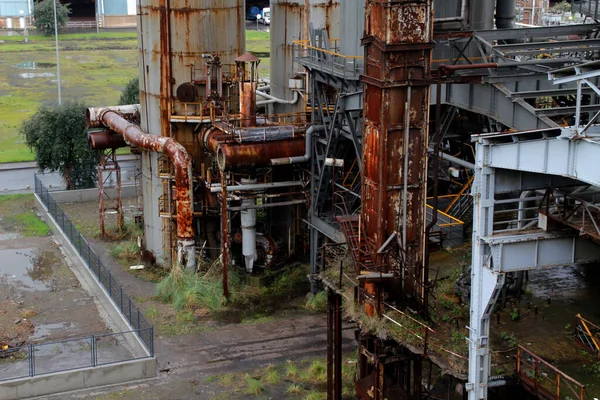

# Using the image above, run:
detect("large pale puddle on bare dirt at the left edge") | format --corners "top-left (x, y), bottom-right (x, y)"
top-left (0, 248), bottom-right (55, 291)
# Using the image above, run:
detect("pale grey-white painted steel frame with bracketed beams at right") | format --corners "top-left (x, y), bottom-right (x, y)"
top-left (467, 63), bottom-right (600, 400)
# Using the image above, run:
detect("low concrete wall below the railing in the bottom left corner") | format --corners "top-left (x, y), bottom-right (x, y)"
top-left (0, 358), bottom-right (156, 400)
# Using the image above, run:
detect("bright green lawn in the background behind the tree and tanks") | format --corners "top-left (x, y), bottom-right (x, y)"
top-left (0, 31), bottom-right (269, 163)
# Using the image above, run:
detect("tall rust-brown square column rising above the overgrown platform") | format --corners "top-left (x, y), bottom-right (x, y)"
top-left (361, 0), bottom-right (433, 310)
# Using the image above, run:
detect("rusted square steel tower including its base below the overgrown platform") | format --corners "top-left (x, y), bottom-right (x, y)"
top-left (354, 0), bottom-right (433, 400)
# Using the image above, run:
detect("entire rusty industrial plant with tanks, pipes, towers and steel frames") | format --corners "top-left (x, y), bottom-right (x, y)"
top-left (78, 0), bottom-right (600, 400)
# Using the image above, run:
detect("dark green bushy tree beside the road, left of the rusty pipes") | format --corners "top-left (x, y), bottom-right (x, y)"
top-left (20, 101), bottom-right (99, 190)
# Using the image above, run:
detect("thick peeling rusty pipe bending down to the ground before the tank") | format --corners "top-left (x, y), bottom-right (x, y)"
top-left (87, 109), bottom-right (196, 268)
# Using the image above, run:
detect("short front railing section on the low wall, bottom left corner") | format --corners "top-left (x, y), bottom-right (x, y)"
top-left (0, 327), bottom-right (152, 381)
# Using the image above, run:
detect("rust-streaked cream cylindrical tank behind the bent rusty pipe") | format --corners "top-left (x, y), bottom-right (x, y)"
top-left (138, 0), bottom-right (246, 266)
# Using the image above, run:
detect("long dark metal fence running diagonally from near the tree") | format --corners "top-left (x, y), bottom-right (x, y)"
top-left (35, 175), bottom-right (154, 357)
